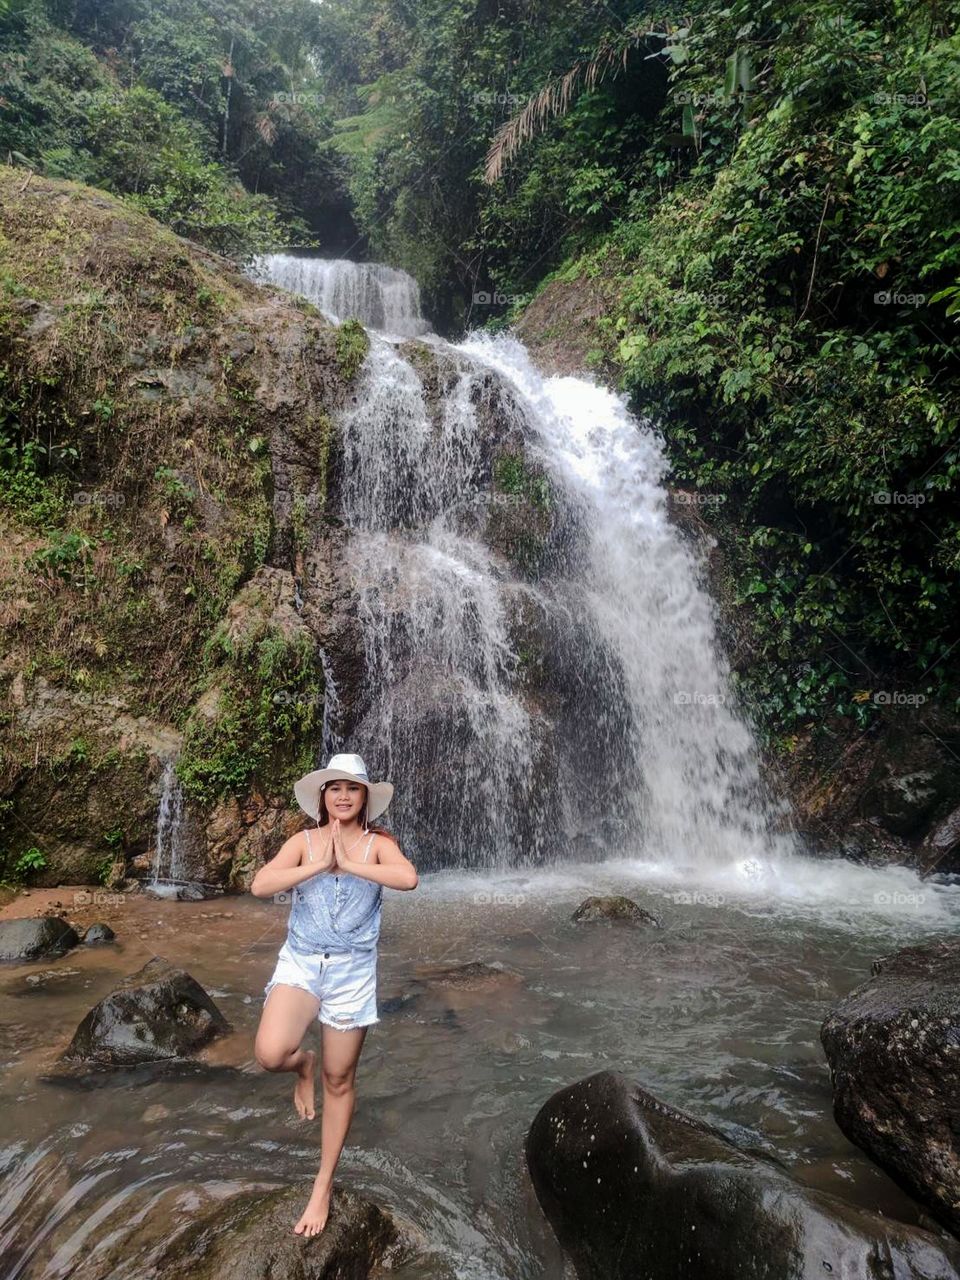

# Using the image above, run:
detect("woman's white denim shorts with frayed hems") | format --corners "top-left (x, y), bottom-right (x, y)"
top-left (264, 942), bottom-right (380, 1030)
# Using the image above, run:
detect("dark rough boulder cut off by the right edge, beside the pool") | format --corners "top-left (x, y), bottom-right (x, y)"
top-left (820, 941), bottom-right (960, 1235)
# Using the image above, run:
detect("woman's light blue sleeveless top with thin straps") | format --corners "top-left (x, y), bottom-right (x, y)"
top-left (287, 829), bottom-right (383, 955)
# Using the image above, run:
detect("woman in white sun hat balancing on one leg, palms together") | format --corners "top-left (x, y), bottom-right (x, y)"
top-left (250, 754), bottom-right (419, 1236)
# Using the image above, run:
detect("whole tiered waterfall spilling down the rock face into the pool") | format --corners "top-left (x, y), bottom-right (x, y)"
top-left (253, 256), bottom-right (790, 876)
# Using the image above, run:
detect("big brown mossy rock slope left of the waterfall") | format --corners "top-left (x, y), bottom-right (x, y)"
top-left (0, 166), bottom-right (357, 882)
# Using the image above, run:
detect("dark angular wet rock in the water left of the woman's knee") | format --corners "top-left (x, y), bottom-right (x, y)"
top-left (61, 956), bottom-right (230, 1068)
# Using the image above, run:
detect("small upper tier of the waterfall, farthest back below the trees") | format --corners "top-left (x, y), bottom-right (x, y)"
top-left (251, 253), bottom-right (430, 337)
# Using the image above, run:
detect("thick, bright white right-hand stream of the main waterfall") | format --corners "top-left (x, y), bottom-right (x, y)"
top-left (460, 335), bottom-right (790, 876)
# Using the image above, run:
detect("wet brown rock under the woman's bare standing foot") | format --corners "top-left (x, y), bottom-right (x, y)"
top-left (152, 1184), bottom-right (427, 1280)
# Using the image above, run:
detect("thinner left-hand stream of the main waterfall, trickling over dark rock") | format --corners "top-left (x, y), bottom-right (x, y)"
top-left (339, 337), bottom-right (539, 863)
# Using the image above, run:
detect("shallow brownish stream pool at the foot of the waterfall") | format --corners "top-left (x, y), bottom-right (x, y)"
top-left (0, 860), bottom-right (960, 1280)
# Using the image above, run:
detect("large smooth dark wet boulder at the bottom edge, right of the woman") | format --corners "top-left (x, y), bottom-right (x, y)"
top-left (526, 1071), bottom-right (960, 1280)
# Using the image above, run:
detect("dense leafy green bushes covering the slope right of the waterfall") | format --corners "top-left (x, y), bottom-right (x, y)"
top-left (602, 4), bottom-right (960, 727)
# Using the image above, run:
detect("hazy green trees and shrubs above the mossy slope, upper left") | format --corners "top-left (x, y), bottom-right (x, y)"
top-left (0, 0), bottom-right (343, 259)
